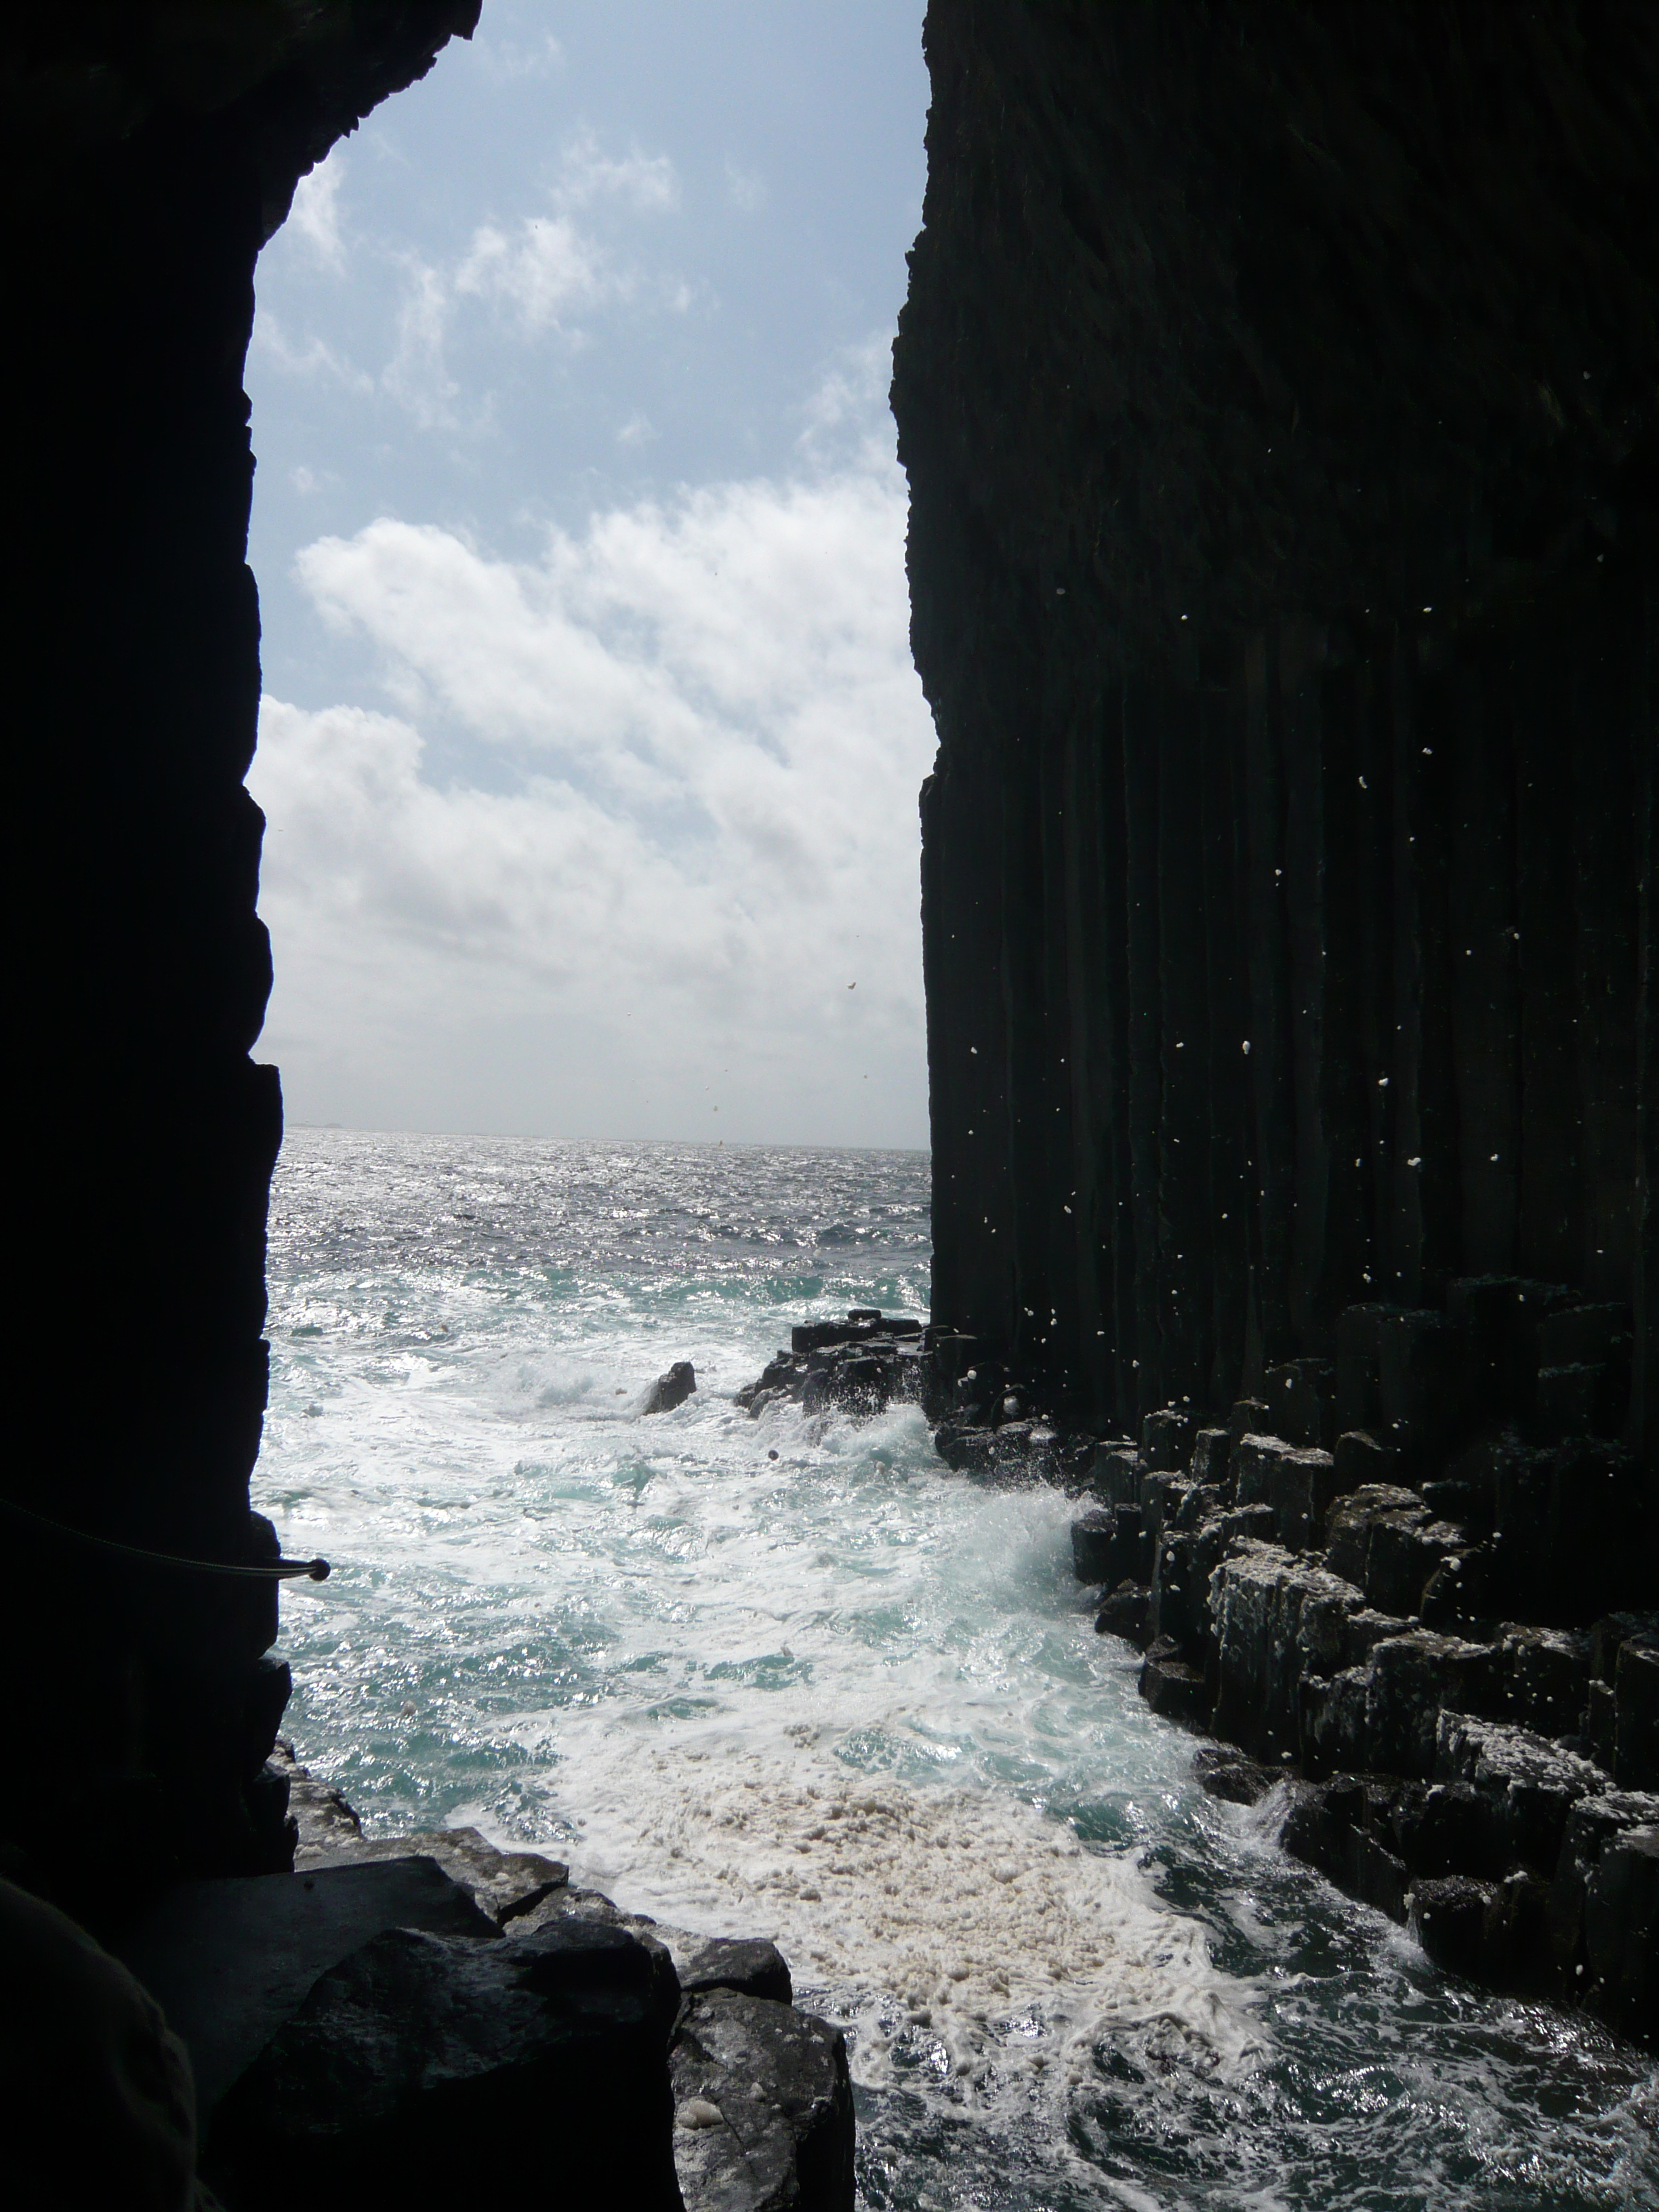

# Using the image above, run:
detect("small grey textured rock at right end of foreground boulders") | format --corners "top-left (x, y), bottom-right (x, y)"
top-left (668, 1991), bottom-right (854, 2212)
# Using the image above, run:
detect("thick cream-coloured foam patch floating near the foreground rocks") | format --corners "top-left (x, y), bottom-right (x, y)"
top-left (546, 1727), bottom-right (1263, 2086)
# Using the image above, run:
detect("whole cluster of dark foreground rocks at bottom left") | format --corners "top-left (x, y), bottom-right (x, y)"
top-left (162, 1743), bottom-right (854, 2212)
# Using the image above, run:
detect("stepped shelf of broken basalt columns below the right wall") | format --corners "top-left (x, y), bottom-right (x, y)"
top-left (739, 1276), bottom-right (1659, 2042)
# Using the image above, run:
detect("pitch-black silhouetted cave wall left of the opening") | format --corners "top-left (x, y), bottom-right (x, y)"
top-left (0, 0), bottom-right (478, 1925)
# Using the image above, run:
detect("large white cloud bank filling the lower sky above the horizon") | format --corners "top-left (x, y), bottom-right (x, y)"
top-left (250, 442), bottom-right (931, 1141)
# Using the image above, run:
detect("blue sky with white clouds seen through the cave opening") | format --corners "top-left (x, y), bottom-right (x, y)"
top-left (248, 13), bottom-right (936, 1146)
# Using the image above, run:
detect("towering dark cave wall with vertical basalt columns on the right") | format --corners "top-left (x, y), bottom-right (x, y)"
top-left (894, 0), bottom-right (1659, 1458)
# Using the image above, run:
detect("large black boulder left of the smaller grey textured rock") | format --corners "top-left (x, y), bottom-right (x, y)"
top-left (203, 1918), bottom-right (685, 2212)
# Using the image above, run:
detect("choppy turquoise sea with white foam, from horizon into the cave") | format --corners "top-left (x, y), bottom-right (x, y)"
top-left (257, 1128), bottom-right (1659, 2212)
